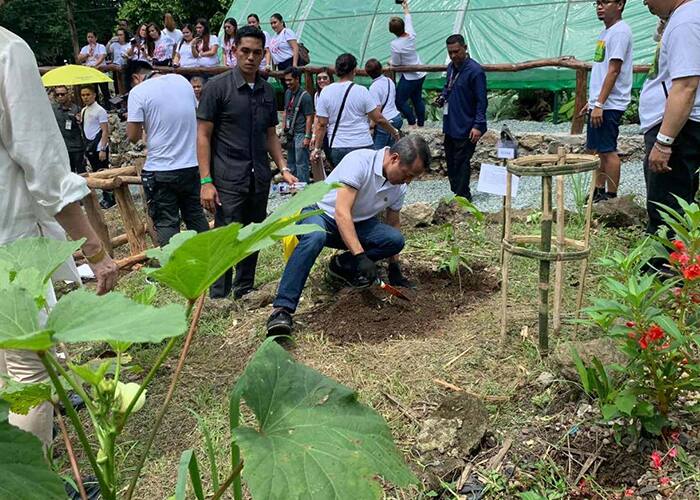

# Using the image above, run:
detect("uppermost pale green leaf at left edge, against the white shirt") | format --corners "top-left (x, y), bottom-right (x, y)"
top-left (0, 238), bottom-right (85, 281)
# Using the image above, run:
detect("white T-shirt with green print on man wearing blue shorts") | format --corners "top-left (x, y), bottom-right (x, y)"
top-left (588, 21), bottom-right (633, 111)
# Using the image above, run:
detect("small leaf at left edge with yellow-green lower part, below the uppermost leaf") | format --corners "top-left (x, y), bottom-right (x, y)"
top-left (0, 288), bottom-right (52, 351)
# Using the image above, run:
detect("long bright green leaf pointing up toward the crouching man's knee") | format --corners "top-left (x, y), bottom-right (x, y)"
top-left (150, 182), bottom-right (335, 300)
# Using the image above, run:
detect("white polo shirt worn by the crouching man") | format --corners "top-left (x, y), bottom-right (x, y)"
top-left (318, 148), bottom-right (408, 222)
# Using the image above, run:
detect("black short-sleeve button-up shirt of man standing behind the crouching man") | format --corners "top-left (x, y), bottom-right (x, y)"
top-left (197, 67), bottom-right (278, 193)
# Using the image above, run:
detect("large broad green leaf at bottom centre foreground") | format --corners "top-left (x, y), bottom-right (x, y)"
top-left (233, 339), bottom-right (417, 500)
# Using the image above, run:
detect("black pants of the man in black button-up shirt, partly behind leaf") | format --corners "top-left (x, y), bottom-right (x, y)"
top-left (209, 179), bottom-right (270, 299)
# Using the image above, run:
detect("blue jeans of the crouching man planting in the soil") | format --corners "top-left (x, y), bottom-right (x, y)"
top-left (273, 206), bottom-right (405, 313)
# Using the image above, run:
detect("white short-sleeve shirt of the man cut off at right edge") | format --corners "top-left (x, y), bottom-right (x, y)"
top-left (639, 0), bottom-right (700, 132)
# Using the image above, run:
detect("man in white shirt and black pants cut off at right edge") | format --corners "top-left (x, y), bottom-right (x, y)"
top-left (639, 0), bottom-right (700, 240)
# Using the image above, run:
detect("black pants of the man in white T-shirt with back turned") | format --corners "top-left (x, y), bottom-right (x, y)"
top-left (141, 167), bottom-right (209, 246)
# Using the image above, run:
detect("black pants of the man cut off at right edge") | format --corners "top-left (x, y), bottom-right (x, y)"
top-left (644, 120), bottom-right (700, 234)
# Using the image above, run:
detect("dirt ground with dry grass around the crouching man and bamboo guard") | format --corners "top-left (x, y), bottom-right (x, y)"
top-left (61, 205), bottom-right (700, 500)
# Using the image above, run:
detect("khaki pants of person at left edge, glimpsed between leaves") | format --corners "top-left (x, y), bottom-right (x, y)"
top-left (0, 283), bottom-right (56, 447)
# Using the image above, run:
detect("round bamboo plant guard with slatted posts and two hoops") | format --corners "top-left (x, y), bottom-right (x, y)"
top-left (501, 148), bottom-right (600, 356)
